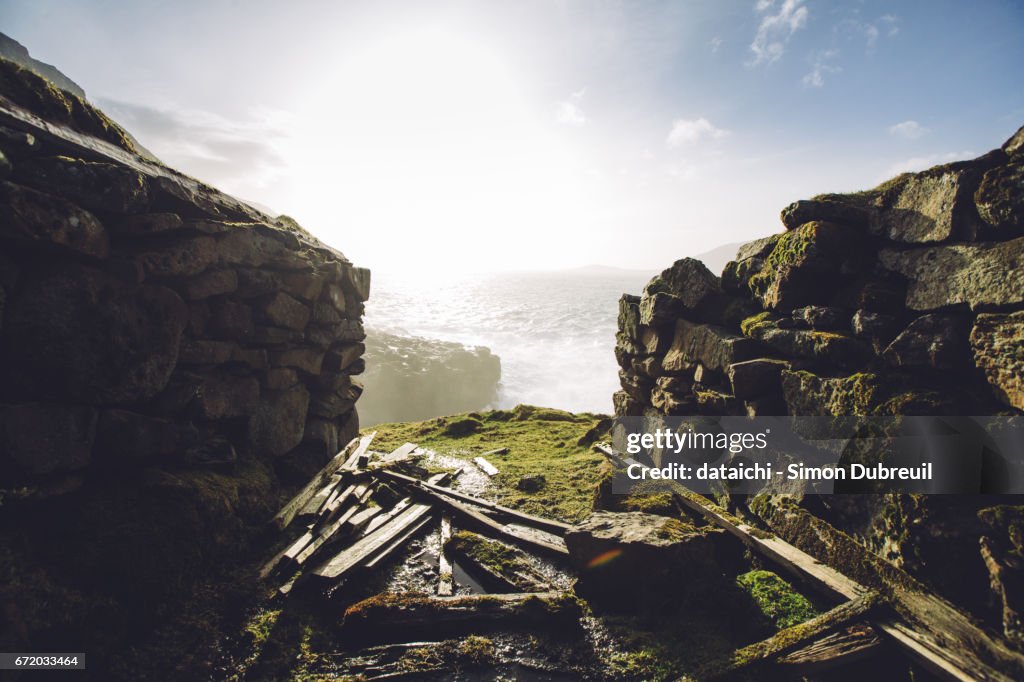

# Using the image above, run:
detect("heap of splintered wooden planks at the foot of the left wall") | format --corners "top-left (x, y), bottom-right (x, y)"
top-left (260, 433), bottom-right (569, 596)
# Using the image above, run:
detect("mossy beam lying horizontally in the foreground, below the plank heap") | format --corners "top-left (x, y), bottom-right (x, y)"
top-left (342, 592), bottom-right (581, 641)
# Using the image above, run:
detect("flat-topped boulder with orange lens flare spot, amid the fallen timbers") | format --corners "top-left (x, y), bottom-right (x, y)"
top-left (565, 511), bottom-right (722, 608)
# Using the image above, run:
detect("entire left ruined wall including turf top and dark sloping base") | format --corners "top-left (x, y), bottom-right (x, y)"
top-left (0, 59), bottom-right (370, 650)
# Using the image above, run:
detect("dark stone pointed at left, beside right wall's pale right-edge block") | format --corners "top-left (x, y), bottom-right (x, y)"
top-left (882, 313), bottom-right (968, 369)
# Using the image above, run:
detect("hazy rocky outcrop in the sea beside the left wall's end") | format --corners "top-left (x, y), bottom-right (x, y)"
top-left (359, 330), bottom-right (502, 425)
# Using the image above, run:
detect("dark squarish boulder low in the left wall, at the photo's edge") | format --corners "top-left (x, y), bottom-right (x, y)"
top-left (0, 402), bottom-right (96, 476)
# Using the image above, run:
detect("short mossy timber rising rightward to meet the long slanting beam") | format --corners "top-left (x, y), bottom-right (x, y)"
top-left (698, 592), bottom-right (881, 679)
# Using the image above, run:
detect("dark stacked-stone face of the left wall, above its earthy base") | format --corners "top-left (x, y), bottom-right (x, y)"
top-left (0, 69), bottom-right (370, 491)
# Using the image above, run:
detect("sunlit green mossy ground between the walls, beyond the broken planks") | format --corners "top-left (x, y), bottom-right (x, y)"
top-left (372, 406), bottom-right (604, 522)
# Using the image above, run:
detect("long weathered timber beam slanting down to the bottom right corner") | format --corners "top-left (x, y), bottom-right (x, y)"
top-left (595, 443), bottom-right (1024, 682)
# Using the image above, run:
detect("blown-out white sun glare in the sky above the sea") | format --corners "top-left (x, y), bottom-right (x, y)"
top-left (290, 29), bottom-right (583, 270)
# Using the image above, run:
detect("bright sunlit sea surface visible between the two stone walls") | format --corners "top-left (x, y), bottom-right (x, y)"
top-left (366, 269), bottom-right (653, 413)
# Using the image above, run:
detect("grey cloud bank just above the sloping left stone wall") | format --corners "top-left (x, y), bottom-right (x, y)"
top-left (98, 99), bottom-right (288, 191)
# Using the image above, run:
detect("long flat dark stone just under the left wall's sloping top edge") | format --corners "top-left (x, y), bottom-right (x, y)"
top-left (15, 157), bottom-right (150, 213)
